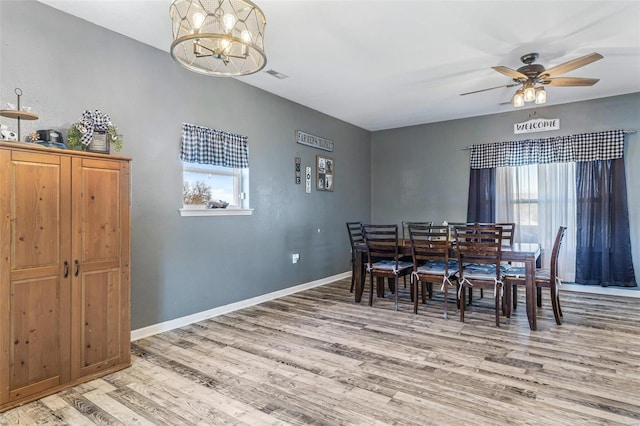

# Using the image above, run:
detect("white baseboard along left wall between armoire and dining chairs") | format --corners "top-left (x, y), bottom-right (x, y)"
top-left (131, 271), bottom-right (351, 341)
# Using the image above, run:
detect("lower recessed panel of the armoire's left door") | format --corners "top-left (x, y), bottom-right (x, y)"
top-left (9, 275), bottom-right (61, 397)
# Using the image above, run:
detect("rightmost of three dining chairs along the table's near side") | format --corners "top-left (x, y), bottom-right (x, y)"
top-left (455, 226), bottom-right (503, 327)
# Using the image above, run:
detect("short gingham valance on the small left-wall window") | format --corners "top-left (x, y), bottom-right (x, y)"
top-left (180, 123), bottom-right (249, 169)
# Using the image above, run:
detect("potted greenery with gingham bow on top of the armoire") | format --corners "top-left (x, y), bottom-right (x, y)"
top-left (67, 110), bottom-right (124, 154)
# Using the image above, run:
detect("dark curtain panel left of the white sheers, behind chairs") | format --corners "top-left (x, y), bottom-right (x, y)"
top-left (467, 168), bottom-right (496, 222)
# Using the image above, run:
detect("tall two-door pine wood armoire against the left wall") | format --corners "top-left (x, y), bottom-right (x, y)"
top-left (0, 142), bottom-right (131, 411)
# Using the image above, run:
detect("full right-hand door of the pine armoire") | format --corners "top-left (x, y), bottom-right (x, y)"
top-left (71, 158), bottom-right (129, 378)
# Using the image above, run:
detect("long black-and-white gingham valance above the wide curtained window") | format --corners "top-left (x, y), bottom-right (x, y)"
top-left (469, 130), bottom-right (625, 169)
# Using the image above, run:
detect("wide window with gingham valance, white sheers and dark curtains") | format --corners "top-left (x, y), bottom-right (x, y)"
top-left (468, 130), bottom-right (637, 286)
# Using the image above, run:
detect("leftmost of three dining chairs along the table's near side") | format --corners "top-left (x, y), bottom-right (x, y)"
top-left (362, 224), bottom-right (413, 311)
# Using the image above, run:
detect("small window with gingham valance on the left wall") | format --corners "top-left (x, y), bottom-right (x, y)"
top-left (180, 123), bottom-right (249, 215)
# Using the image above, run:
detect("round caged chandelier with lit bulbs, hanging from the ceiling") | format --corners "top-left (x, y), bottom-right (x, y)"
top-left (169, 0), bottom-right (267, 76)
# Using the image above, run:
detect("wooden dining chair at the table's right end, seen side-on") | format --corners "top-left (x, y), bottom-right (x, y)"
top-left (505, 226), bottom-right (567, 325)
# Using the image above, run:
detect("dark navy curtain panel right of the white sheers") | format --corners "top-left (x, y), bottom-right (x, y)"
top-left (576, 158), bottom-right (637, 287)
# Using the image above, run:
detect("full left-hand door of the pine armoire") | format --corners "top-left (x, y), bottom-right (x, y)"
top-left (0, 149), bottom-right (71, 404)
